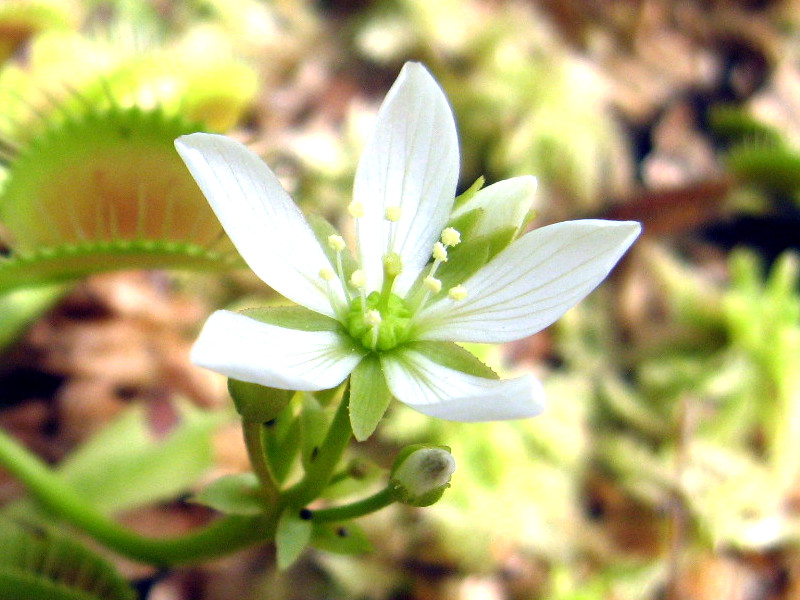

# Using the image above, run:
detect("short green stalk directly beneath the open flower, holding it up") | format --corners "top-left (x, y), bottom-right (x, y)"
top-left (283, 382), bottom-right (353, 506)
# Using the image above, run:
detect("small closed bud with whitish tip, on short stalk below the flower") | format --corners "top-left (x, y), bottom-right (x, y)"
top-left (391, 444), bottom-right (456, 506)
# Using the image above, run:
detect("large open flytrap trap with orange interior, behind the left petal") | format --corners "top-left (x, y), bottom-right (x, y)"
top-left (0, 107), bottom-right (240, 291)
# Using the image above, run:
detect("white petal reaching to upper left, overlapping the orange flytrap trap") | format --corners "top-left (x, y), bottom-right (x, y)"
top-left (175, 133), bottom-right (344, 316)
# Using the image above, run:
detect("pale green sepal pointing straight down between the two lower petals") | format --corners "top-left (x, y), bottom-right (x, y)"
top-left (350, 354), bottom-right (392, 442)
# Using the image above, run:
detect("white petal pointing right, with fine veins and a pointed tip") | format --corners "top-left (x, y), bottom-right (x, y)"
top-left (414, 219), bottom-right (641, 343)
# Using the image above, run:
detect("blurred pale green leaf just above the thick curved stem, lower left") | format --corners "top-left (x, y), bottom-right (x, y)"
top-left (58, 405), bottom-right (228, 512)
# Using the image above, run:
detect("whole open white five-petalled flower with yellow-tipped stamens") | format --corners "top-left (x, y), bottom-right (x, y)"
top-left (176, 63), bottom-right (640, 439)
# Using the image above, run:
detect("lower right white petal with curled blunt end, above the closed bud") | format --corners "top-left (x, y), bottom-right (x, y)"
top-left (381, 350), bottom-right (544, 421)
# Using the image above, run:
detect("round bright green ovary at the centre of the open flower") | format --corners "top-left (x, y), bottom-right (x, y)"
top-left (346, 292), bottom-right (411, 350)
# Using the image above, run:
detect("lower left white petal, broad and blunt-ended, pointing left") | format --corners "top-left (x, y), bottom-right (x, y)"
top-left (191, 310), bottom-right (363, 391)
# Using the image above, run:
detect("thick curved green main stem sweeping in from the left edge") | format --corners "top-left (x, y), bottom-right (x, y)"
top-left (0, 430), bottom-right (276, 566)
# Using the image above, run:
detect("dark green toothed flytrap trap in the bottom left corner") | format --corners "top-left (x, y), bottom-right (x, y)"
top-left (0, 521), bottom-right (136, 600)
